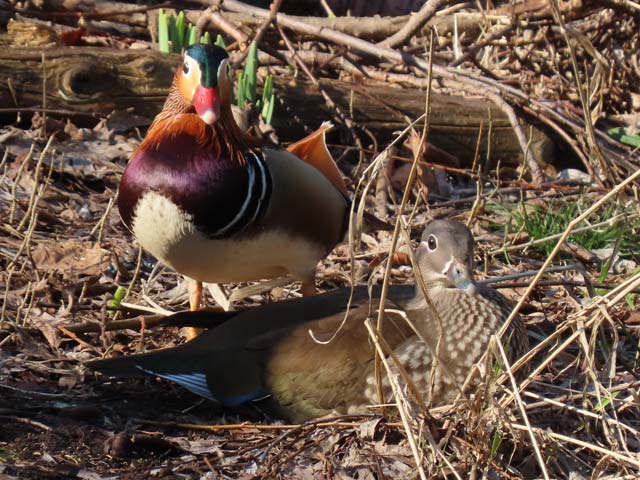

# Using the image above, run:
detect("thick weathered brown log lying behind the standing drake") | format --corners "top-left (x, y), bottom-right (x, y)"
top-left (0, 48), bottom-right (550, 165)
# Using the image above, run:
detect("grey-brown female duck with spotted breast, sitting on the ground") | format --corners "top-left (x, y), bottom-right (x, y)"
top-left (88, 220), bottom-right (528, 421)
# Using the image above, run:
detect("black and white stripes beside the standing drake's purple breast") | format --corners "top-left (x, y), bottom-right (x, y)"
top-left (209, 152), bottom-right (272, 238)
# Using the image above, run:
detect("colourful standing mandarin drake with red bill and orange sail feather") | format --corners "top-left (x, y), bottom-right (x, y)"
top-left (118, 44), bottom-right (349, 316)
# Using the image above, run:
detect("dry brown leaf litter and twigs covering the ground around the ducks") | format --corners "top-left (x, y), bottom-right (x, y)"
top-left (0, 1), bottom-right (640, 479)
